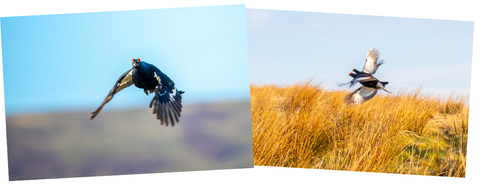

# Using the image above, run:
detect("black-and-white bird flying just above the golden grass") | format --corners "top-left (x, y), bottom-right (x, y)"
top-left (339, 48), bottom-right (390, 105)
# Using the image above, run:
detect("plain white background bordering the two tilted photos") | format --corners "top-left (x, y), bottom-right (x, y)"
top-left (0, 0), bottom-right (480, 184)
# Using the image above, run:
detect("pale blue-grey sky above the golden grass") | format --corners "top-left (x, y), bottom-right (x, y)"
top-left (247, 9), bottom-right (473, 96)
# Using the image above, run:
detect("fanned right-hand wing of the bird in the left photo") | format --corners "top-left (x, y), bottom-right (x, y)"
top-left (150, 77), bottom-right (184, 126)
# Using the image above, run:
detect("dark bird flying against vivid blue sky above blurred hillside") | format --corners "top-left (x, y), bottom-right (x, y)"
top-left (90, 59), bottom-right (185, 126)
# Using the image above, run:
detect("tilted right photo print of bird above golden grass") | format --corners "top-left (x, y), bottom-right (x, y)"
top-left (247, 9), bottom-right (473, 177)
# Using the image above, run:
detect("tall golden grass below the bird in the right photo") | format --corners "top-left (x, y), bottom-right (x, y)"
top-left (251, 82), bottom-right (469, 177)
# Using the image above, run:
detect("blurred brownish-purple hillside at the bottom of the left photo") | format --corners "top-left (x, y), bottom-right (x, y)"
top-left (6, 102), bottom-right (253, 180)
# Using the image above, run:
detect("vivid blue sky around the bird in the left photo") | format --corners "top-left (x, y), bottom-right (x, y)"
top-left (0, 5), bottom-right (249, 115)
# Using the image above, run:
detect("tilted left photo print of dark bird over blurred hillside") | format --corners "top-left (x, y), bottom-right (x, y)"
top-left (0, 5), bottom-right (253, 181)
